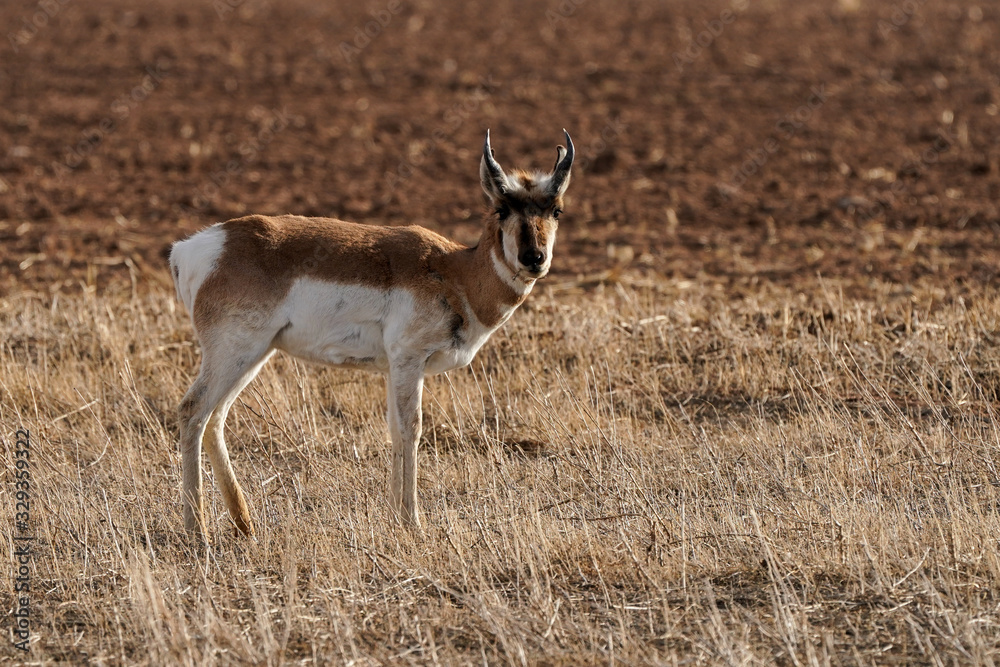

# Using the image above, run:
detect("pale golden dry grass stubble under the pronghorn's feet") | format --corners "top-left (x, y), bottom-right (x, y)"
top-left (0, 268), bottom-right (1000, 665)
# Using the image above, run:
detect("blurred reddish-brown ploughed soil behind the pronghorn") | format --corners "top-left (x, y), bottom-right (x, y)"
top-left (0, 0), bottom-right (1000, 293)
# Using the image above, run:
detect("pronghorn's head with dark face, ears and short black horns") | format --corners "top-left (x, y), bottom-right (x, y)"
top-left (479, 130), bottom-right (574, 280)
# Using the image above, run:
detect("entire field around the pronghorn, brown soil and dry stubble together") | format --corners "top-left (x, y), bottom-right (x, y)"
top-left (0, 0), bottom-right (1000, 666)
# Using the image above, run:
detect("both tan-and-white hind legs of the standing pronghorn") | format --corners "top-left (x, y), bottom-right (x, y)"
top-left (179, 337), bottom-right (272, 536)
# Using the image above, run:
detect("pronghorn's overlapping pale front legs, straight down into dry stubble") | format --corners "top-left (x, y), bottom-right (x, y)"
top-left (388, 360), bottom-right (424, 528)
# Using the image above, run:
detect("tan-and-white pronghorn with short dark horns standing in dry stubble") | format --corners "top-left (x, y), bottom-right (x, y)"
top-left (170, 130), bottom-right (574, 535)
